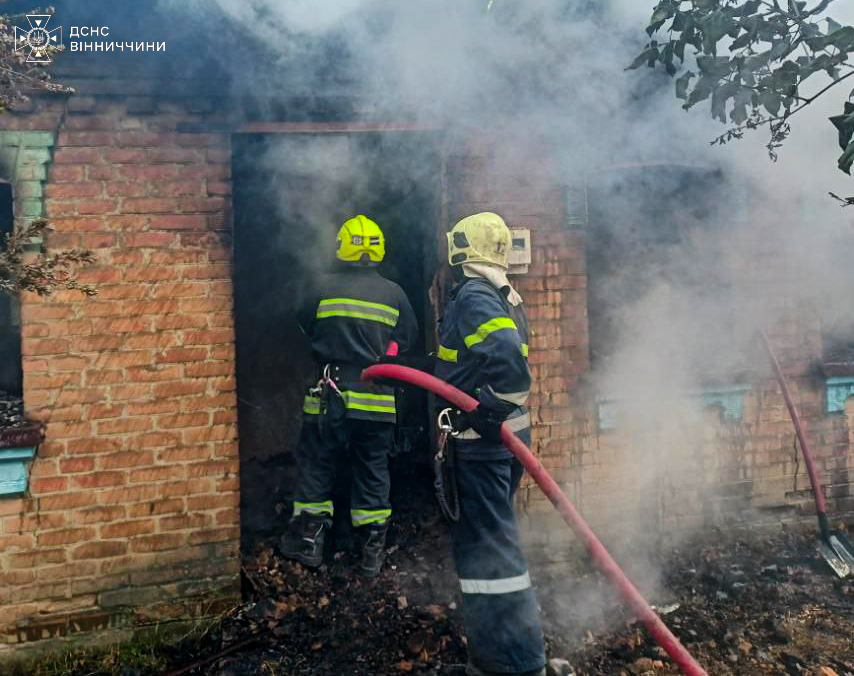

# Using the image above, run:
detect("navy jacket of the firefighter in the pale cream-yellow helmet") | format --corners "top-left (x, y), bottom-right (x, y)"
top-left (436, 278), bottom-right (531, 456)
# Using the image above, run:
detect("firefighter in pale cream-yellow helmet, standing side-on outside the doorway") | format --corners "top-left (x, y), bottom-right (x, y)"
top-left (436, 213), bottom-right (546, 676)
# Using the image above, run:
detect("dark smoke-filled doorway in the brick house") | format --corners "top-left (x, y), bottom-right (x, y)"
top-left (234, 132), bottom-right (441, 546)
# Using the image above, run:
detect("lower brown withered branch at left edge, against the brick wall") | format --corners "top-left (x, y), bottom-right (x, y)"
top-left (0, 219), bottom-right (96, 296)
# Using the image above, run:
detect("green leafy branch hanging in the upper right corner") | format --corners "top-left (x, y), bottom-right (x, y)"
top-left (629, 0), bottom-right (854, 173)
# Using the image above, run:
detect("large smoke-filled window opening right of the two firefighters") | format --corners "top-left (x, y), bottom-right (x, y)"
top-left (586, 164), bottom-right (746, 379)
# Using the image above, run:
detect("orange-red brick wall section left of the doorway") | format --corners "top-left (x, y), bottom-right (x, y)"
top-left (0, 97), bottom-right (239, 650)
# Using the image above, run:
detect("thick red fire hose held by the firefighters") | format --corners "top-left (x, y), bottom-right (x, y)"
top-left (362, 364), bottom-right (708, 676)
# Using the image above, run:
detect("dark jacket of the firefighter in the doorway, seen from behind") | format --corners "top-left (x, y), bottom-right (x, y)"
top-left (299, 265), bottom-right (418, 423)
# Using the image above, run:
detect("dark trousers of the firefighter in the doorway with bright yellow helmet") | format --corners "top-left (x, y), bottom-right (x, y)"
top-left (294, 395), bottom-right (394, 527)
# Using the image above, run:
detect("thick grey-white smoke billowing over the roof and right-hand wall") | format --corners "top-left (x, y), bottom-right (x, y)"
top-left (159, 0), bottom-right (854, 632)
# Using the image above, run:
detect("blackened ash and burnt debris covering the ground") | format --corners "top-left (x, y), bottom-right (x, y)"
top-left (154, 476), bottom-right (854, 676)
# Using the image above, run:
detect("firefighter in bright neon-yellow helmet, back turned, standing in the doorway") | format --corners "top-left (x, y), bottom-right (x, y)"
top-left (281, 215), bottom-right (418, 576)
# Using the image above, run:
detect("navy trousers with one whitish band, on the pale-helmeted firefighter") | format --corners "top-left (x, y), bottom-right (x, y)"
top-left (451, 435), bottom-right (546, 674)
